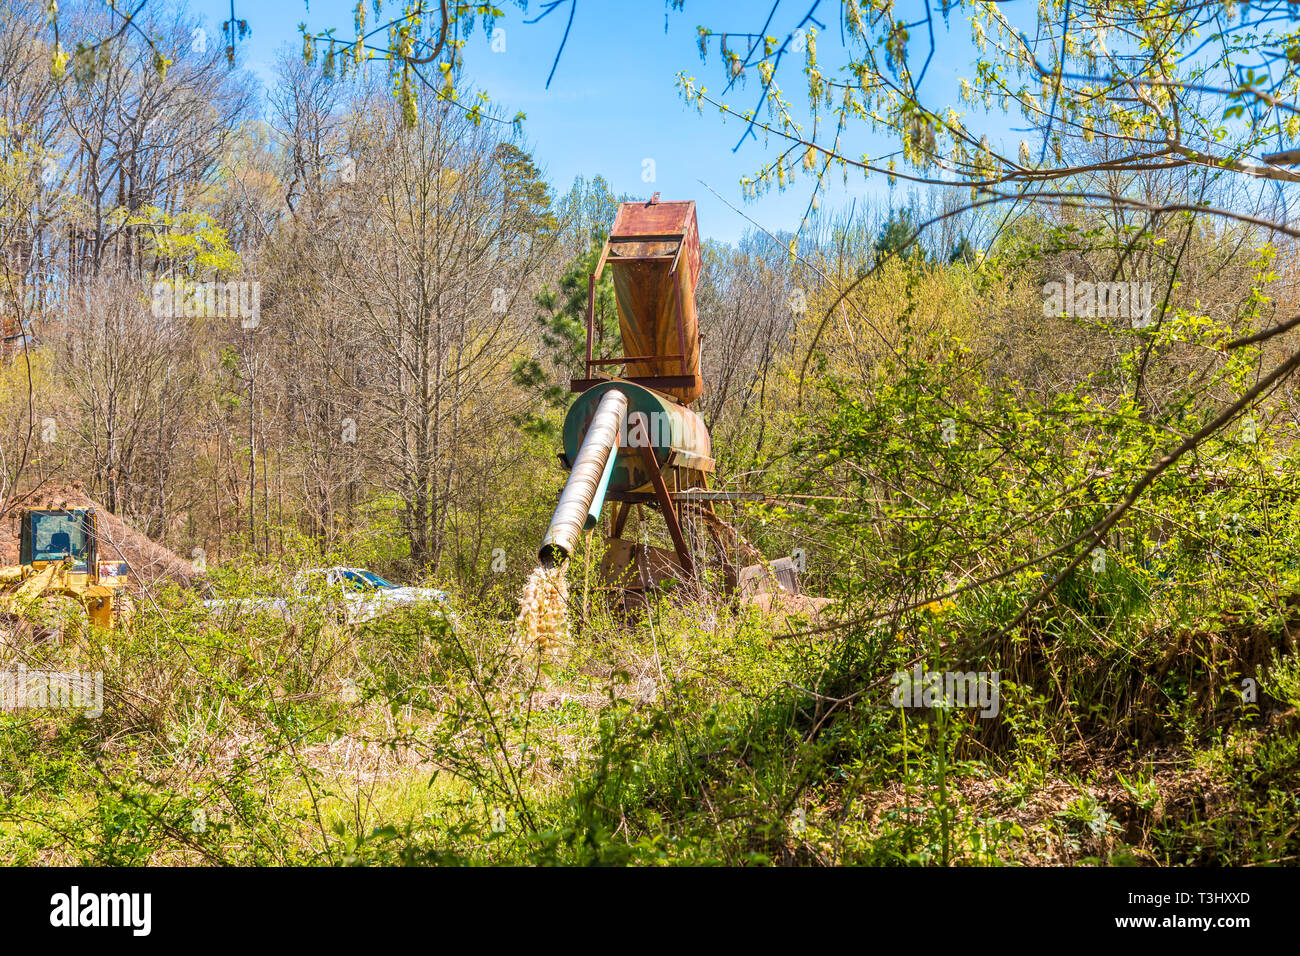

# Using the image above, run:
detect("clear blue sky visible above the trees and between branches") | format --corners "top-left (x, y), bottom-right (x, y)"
top-left (190, 0), bottom-right (970, 242)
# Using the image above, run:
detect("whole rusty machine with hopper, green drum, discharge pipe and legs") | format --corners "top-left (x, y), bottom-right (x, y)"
top-left (538, 198), bottom-right (780, 608)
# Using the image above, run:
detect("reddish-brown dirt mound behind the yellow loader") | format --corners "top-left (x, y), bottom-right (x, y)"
top-left (0, 483), bottom-right (198, 584)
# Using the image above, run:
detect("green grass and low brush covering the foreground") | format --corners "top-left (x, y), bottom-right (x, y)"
top-left (0, 522), bottom-right (1300, 865)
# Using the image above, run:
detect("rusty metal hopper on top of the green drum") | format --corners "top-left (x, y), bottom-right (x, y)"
top-left (573, 199), bottom-right (705, 405)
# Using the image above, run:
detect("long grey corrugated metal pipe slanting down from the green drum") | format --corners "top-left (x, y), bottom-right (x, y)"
top-left (537, 389), bottom-right (628, 567)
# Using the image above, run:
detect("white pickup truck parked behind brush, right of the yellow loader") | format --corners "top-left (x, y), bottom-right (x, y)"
top-left (203, 566), bottom-right (456, 624)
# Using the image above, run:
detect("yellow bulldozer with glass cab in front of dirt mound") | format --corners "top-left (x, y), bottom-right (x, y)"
top-left (0, 509), bottom-right (134, 640)
